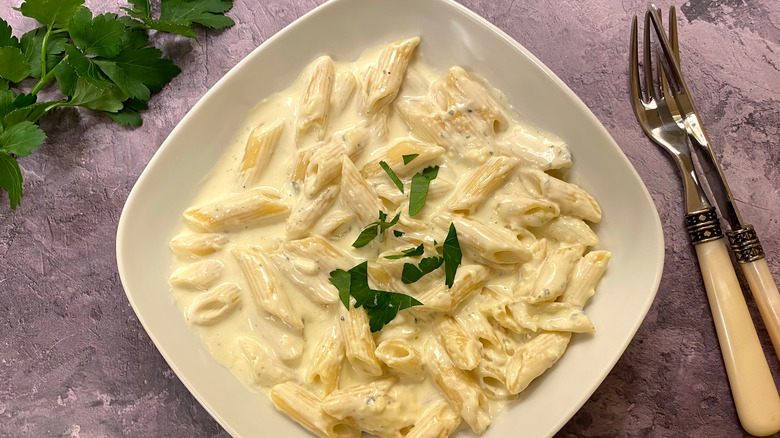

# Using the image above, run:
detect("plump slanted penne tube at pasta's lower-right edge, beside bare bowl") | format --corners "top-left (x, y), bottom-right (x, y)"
top-left (506, 332), bottom-right (571, 394)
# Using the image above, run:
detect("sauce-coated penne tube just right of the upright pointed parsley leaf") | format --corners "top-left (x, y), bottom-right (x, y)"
top-left (433, 215), bottom-right (532, 265)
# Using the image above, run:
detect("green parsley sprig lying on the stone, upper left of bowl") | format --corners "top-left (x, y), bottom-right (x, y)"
top-left (0, 0), bottom-right (234, 209)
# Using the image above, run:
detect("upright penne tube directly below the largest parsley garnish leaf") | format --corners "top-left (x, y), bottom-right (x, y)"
top-left (338, 305), bottom-right (382, 377)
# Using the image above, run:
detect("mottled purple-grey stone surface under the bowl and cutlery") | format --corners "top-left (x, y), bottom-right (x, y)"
top-left (0, 0), bottom-right (780, 438)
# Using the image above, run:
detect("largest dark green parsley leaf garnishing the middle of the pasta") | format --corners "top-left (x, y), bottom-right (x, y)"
top-left (329, 262), bottom-right (422, 332)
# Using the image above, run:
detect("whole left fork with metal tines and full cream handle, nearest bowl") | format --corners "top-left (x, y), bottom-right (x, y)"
top-left (629, 12), bottom-right (780, 436)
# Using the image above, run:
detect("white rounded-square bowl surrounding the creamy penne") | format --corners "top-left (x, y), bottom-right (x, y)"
top-left (117, 0), bottom-right (664, 438)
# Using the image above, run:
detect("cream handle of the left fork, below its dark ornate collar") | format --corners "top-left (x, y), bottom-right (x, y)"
top-left (695, 239), bottom-right (780, 436)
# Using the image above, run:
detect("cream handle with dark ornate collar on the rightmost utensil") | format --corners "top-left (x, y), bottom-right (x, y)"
top-left (727, 225), bottom-right (780, 358)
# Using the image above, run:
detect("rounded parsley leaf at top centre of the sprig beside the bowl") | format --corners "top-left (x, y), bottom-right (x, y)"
top-left (68, 7), bottom-right (125, 58)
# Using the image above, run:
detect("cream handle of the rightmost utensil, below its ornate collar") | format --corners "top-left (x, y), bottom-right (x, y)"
top-left (741, 259), bottom-right (780, 358)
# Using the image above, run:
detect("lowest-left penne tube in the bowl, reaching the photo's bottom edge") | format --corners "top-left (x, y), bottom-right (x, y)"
top-left (271, 382), bottom-right (360, 438)
